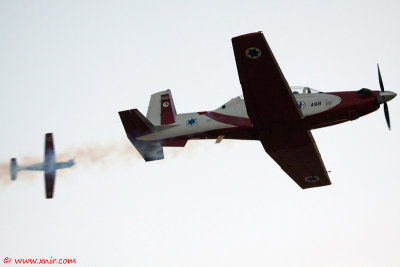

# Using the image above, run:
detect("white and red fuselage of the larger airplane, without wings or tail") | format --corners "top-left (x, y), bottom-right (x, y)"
top-left (137, 87), bottom-right (380, 146)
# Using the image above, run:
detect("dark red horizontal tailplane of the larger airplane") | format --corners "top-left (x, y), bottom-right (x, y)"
top-left (119, 109), bottom-right (164, 161)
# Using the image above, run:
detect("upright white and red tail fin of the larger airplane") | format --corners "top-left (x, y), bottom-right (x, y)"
top-left (146, 89), bottom-right (176, 125)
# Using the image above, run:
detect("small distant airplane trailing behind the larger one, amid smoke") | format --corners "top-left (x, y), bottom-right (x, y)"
top-left (10, 133), bottom-right (75, 198)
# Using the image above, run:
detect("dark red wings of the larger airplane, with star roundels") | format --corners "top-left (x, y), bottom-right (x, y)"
top-left (232, 32), bottom-right (331, 189)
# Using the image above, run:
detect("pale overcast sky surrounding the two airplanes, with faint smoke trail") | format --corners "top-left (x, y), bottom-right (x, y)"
top-left (0, 0), bottom-right (400, 267)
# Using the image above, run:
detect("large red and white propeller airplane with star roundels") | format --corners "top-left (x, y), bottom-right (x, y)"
top-left (119, 32), bottom-right (396, 189)
